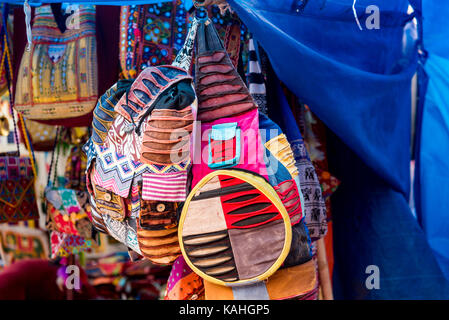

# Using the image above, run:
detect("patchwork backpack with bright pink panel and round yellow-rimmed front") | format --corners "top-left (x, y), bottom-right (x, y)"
top-left (179, 19), bottom-right (317, 299)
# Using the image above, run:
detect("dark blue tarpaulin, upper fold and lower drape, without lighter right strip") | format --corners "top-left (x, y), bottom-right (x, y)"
top-left (228, 0), bottom-right (449, 299)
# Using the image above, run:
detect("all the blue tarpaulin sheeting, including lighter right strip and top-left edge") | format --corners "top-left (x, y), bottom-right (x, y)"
top-left (0, 0), bottom-right (449, 299)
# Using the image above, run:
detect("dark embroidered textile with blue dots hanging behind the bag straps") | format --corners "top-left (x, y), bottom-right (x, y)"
top-left (119, 0), bottom-right (246, 79)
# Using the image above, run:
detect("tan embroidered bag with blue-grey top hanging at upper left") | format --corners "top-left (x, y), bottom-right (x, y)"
top-left (15, 5), bottom-right (98, 126)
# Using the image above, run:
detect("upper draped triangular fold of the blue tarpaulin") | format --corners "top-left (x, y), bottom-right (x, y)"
top-left (229, 0), bottom-right (416, 195)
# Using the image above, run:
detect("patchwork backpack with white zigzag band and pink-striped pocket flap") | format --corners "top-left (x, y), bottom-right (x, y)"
top-left (85, 20), bottom-right (197, 264)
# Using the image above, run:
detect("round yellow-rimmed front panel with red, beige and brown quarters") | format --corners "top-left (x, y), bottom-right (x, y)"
top-left (178, 169), bottom-right (292, 286)
